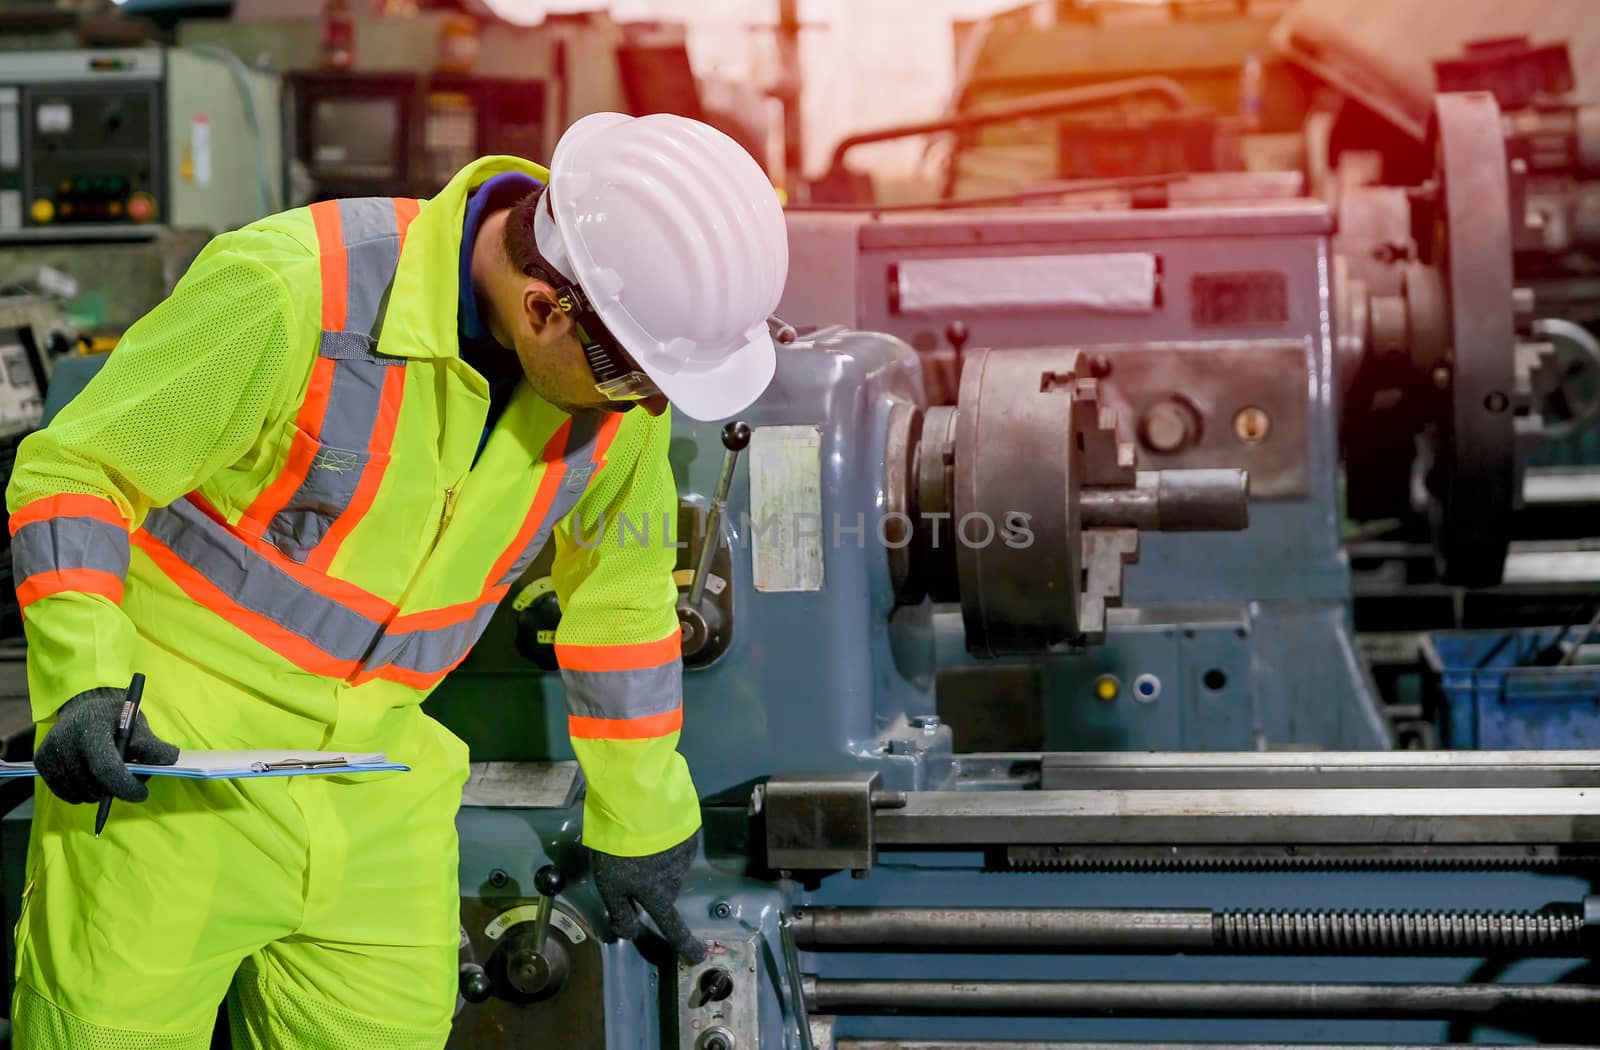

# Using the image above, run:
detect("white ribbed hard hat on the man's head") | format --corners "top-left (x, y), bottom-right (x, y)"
top-left (534, 114), bottom-right (789, 421)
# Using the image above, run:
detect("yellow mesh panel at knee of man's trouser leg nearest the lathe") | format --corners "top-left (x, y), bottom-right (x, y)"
top-left (227, 965), bottom-right (450, 1050)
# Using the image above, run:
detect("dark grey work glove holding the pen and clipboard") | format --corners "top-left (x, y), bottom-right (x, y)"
top-left (34, 688), bottom-right (178, 802)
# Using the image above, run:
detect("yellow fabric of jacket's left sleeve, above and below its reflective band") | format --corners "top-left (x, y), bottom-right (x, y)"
top-left (6, 230), bottom-right (317, 720)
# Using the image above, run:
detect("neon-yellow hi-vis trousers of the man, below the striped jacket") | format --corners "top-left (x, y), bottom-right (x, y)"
top-left (11, 645), bottom-right (467, 1050)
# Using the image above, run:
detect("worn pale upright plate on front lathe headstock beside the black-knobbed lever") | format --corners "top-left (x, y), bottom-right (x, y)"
top-left (739, 426), bottom-right (827, 591)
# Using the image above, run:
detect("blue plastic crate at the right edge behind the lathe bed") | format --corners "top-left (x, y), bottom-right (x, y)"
top-left (1422, 627), bottom-right (1600, 751)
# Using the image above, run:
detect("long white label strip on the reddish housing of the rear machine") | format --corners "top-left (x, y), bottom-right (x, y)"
top-left (896, 251), bottom-right (1158, 314)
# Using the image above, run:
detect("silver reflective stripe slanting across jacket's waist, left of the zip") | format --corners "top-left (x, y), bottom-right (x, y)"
top-left (144, 499), bottom-right (382, 661)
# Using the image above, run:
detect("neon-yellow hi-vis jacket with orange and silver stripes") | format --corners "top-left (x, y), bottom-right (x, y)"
top-left (6, 157), bottom-right (699, 856)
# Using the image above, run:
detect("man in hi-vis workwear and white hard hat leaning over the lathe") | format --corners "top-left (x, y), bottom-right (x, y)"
top-left (6, 114), bottom-right (787, 1050)
